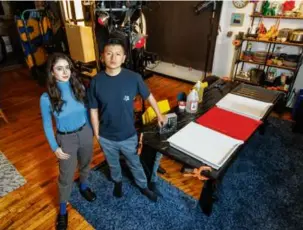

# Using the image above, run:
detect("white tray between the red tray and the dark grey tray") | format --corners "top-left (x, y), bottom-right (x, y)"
top-left (216, 93), bottom-right (273, 120)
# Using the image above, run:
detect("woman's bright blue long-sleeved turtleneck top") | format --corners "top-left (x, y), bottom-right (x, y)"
top-left (40, 81), bottom-right (89, 151)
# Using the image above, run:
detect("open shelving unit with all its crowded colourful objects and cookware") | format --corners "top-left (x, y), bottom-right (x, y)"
top-left (233, 0), bottom-right (303, 107)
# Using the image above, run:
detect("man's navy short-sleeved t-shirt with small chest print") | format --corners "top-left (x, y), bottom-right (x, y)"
top-left (88, 69), bottom-right (150, 141)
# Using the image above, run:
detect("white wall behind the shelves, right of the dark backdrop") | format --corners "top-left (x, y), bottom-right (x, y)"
top-left (213, 1), bottom-right (303, 100)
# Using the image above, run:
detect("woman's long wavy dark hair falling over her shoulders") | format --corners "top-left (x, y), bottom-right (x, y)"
top-left (46, 53), bottom-right (85, 113)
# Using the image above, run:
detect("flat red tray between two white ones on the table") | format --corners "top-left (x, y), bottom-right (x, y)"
top-left (196, 106), bottom-right (263, 141)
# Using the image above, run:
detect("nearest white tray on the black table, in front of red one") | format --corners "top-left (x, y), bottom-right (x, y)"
top-left (168, 122), bottom-right (243, 169)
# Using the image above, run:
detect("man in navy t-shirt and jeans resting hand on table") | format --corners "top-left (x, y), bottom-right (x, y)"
top-left (88, 39), bottom-right (166, 201)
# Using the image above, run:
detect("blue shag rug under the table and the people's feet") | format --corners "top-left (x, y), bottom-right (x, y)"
top-left (71, 118), bottom-right (303, 230)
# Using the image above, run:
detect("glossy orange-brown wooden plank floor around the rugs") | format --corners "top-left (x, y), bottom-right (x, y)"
top-left (0, 69), bottom-right (202, 230)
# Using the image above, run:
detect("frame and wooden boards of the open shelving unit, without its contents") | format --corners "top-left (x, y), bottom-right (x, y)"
top-left (233, 9), bottom-right (303, 104)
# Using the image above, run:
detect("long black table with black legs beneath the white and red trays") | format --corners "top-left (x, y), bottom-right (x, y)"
top-left (141, 79), bottom-right (281, 216)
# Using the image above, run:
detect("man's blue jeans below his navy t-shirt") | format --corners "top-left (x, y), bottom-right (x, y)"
top-left (99, 135), bottom-right (147, 188)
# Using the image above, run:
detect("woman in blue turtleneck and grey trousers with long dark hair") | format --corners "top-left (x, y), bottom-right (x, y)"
top-left (40, 53), bottom-right (96, 230)
